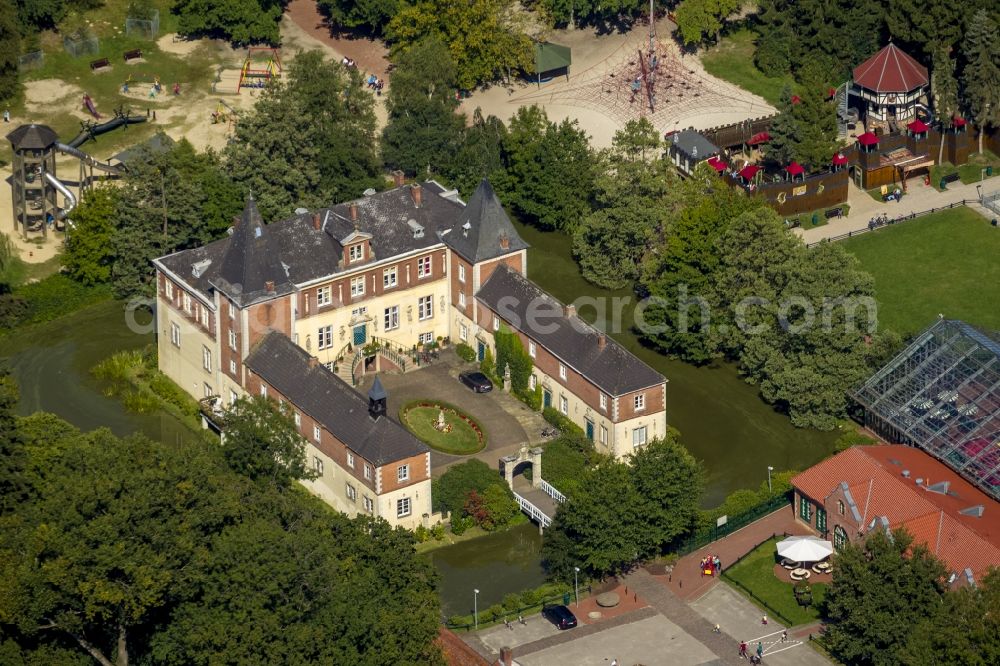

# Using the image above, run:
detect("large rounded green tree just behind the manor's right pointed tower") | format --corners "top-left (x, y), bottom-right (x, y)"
top-left (494, 106), bottom-right (596, 231)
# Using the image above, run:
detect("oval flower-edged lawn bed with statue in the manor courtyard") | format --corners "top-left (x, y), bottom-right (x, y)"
top-left (399, 400), bottom-right (486, 456)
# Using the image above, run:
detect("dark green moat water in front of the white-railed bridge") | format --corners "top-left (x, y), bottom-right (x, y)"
top-left (427, 523), bottom-right (545, 617)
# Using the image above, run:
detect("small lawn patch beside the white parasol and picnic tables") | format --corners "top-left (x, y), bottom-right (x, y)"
top-left (724, 539), bottom-right (827, 626)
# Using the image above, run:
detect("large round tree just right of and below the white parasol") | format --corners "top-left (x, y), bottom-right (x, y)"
top-left (824, 529), bottom-right (946, 666)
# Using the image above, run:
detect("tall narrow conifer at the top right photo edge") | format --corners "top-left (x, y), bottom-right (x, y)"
top-left (962, 9), bottom-right (1000, 153)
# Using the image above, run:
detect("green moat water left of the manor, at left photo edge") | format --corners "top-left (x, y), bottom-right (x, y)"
top-left (0, 301), bottom-right (192, 442)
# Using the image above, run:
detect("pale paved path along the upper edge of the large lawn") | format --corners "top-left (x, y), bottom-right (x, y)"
top-left (795, 178), bottom-right (1000, 243)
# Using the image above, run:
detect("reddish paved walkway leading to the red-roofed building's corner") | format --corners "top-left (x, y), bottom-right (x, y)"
top-left (656, 505), bottom-right (812, 601)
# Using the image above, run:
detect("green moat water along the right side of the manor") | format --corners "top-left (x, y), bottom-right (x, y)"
top-left (515, 223), bottom-right (837, 506)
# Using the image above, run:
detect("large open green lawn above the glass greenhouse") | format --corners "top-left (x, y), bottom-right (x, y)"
top-left (843, 208), bottom-right (1000, 335)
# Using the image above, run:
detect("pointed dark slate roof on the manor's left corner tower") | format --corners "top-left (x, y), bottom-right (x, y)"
top-left (216, 195), bottom-right (288, 304)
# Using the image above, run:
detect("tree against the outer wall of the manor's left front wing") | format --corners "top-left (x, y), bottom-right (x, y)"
top-left (222, 396), bottom-right (317, 488)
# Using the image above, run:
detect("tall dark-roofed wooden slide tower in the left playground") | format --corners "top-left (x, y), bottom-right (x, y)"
top-left (7, 124), bottom-right (60, 238)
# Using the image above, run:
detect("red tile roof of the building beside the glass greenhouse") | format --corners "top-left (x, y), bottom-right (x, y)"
top-left (792, 445), bottom-right (1000, 580)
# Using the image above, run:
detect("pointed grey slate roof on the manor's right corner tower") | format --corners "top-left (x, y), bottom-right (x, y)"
top-left (444, 178), bottom-right (528, 263)
